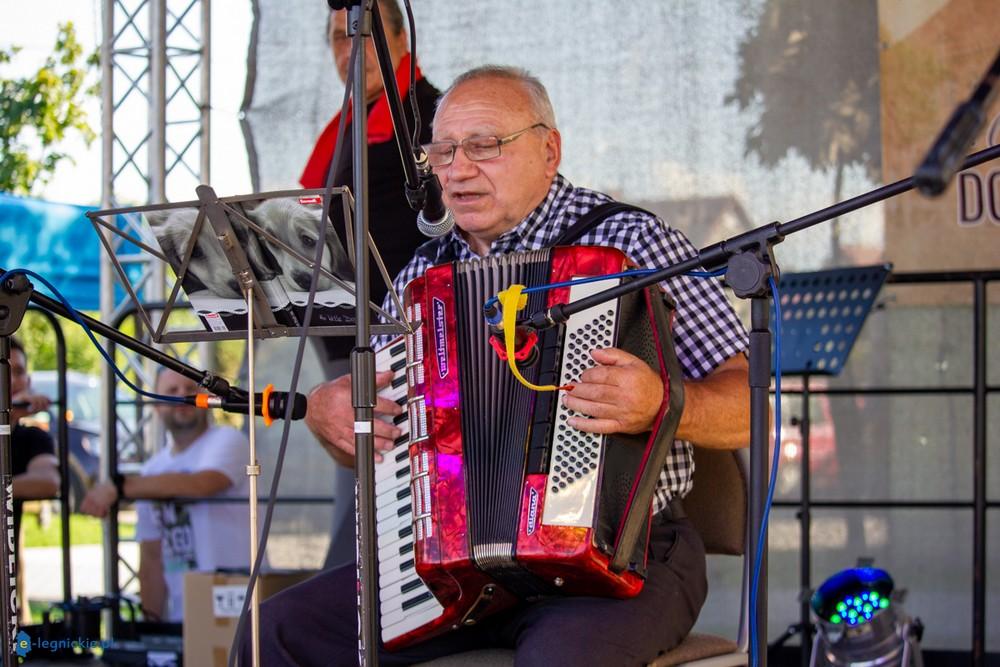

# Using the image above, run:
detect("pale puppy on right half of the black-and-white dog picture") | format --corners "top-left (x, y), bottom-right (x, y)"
top-left (247, 198), bottom-right (352, 292)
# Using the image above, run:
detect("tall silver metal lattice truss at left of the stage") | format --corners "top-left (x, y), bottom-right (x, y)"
top-left (100, 0), bottom-right (211, 617)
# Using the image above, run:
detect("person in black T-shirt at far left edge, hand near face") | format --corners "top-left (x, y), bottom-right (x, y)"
top-left (10, 338), bottom-right (59, 553)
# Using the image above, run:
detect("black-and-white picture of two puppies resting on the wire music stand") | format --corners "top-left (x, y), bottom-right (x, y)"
top-left (145, 197), bottom-right (354, 313)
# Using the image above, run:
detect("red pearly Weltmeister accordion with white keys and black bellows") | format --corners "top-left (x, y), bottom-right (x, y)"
top-left (375, 247), bottom-right (683, 650)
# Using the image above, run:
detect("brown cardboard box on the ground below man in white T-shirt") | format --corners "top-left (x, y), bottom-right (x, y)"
top-left (184, 570), bottom-right (315, 667)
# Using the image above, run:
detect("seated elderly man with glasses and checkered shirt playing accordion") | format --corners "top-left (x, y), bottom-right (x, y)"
top-left (244, 66), bottom-right (749, 666)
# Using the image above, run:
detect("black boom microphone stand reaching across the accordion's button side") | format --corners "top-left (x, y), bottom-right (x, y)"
top-left (526, 146), bottom-right (1000, 667)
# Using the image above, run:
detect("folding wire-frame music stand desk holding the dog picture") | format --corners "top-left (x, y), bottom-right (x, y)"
top-left (86, 185), bottom-right (409, 343)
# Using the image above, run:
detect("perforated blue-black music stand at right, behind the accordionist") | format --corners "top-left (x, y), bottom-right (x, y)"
top-left (775, 264), bottom-right (892, 667)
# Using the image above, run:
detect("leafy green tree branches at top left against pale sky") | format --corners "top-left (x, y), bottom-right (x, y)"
top-left (0, 22), bottom-right (98, 195)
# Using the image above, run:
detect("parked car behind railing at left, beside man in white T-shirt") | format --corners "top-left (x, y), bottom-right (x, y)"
top-left (23, 371), bottom-right (135, 511)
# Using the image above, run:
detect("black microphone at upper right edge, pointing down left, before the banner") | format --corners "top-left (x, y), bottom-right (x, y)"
top-left (913, 48), bottom-right (1000, 197)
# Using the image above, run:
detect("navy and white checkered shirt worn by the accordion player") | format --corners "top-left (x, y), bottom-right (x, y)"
top-left (379, 174), bottom-right (747, 512)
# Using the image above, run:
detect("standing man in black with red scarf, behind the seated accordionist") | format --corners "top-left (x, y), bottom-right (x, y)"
top-left (299, 0), bottom-right (440, 567)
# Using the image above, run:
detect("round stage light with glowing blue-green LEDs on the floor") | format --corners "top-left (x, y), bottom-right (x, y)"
top-left (810, 567), bottom-right (923, 667)
